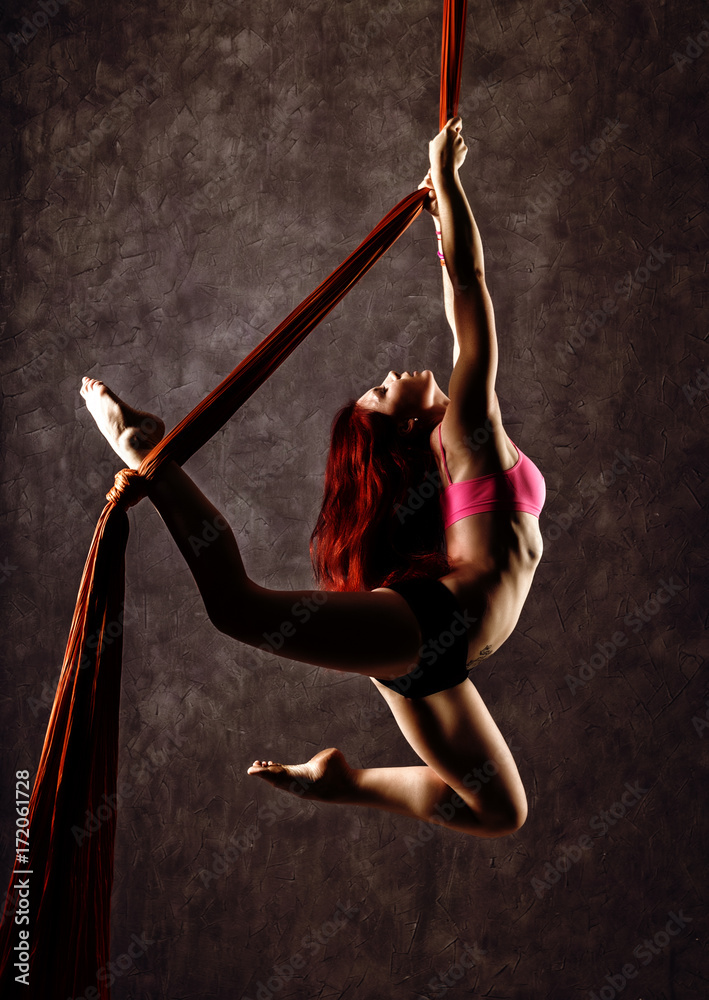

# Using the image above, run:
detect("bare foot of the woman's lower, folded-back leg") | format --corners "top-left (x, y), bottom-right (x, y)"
top-left (248, 747), bottom-right (355, 802)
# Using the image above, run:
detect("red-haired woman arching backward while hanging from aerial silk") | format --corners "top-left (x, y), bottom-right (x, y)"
top-left (81, 118), bottom-right (544, 837)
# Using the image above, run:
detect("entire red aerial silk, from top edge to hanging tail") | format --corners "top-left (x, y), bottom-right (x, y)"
top-left (0, 0), bottom-right (467, 1000)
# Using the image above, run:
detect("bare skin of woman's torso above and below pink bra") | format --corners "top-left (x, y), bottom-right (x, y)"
top-left (430, 396), bottom-right (543, 667)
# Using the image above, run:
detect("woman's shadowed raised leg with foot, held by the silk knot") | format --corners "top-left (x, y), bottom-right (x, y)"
top-left (81, 379), bottom-right (421, 679)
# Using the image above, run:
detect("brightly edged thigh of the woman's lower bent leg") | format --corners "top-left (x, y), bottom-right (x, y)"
top-left (372, 678), bottom-right (527, 822)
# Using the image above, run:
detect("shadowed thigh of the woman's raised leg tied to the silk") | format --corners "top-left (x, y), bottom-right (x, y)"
top-left (210, 583), bottom-right (422, 680)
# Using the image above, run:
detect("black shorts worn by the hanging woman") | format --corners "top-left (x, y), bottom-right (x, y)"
top-left (376, 579), bottom-right (476, 698)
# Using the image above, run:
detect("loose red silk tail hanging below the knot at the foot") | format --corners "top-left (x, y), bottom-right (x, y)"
top-left (0, 504), bottom-right (128, 1000)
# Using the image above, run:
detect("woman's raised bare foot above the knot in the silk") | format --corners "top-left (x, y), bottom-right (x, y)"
top-left (79, 375), bottom-right (165, 469)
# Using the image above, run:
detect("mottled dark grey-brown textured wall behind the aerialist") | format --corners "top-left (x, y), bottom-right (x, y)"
top-left (0, 0), bottom-right (709, 1000)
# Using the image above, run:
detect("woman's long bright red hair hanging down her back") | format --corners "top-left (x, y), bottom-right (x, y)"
top-left (310, 400), bottom-right (449, 590)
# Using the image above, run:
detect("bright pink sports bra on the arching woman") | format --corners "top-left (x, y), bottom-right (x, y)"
top-left (438, 424), bottom-right (546, 528)
